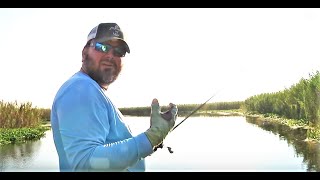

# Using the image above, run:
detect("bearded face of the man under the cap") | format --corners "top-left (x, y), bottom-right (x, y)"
top-left (82, 40), bottom-right (122, 86)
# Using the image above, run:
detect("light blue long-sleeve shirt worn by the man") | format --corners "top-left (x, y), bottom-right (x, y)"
top-left (51, 71), bottom-right (153, 171)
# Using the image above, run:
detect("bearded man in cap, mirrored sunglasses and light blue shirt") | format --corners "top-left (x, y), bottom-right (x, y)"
top-left (51, 23), bottom-right (178, 171)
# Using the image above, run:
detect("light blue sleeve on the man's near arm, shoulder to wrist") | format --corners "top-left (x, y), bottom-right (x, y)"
top-left (55, 80), bottom-right (153, 171)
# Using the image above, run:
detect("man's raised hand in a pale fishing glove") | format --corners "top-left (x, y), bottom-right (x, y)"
top-left (145, 99), bottom-right (178, 148)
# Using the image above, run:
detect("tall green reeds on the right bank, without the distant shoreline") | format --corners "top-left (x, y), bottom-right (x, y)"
top-left (241, 71), bottom-right (320, 141)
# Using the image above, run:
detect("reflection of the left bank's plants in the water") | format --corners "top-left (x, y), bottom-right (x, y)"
top-left (0, 141), bottom-right (41, 172)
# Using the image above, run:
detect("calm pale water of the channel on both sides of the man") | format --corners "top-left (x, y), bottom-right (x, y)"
top-left (0, 116), bottom-right (319, 172)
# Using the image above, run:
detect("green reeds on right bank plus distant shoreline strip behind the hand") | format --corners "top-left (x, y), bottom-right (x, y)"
top-left (120, 71), bottom-right (320, 141)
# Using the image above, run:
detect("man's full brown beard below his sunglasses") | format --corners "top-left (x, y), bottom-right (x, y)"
top-left (83, 55), bottom-right (121, 86)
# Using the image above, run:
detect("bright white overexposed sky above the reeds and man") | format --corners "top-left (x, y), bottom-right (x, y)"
top-left (0, 8), bottom-right (320, 108)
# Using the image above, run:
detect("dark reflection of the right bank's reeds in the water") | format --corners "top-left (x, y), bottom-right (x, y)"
top-left (246, 117), bottom-right (320, 172)
